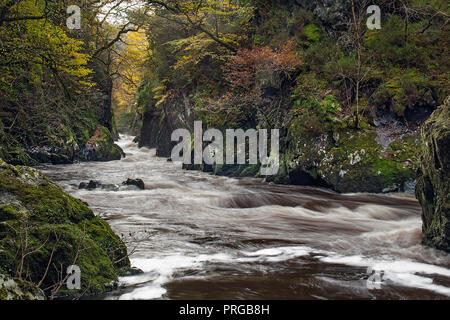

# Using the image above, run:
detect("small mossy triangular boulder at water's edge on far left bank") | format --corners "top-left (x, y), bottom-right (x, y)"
top-left (77, 125), bottom-right (125, 161)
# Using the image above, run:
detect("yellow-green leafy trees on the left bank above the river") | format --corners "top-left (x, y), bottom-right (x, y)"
top-left (0, 0), bottom-right (151, 151)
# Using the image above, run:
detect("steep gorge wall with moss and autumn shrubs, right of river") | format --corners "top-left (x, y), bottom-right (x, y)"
top-left (137, 1), bottom-right (448, 194)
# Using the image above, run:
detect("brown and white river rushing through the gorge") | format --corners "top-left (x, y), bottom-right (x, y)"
top-left (41, 136), bottom-right (450, 299)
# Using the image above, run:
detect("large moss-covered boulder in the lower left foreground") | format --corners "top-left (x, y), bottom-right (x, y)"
top-left (0, 160), bottom-right (130, 295)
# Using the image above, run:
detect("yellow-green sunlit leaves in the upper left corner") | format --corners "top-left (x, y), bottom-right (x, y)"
top-left (0, 0), bottom-right (92, 95)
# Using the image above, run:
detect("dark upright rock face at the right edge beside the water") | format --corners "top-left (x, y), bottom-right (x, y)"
top-left (416, 97), bottom-right (450, 252)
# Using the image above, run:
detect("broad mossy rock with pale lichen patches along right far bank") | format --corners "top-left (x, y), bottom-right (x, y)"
top-left (288, 129), bottom-right (416, 193)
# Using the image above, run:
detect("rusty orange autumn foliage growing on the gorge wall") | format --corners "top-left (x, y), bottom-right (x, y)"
top-left (198, 42), bottom-right (302, 126)
